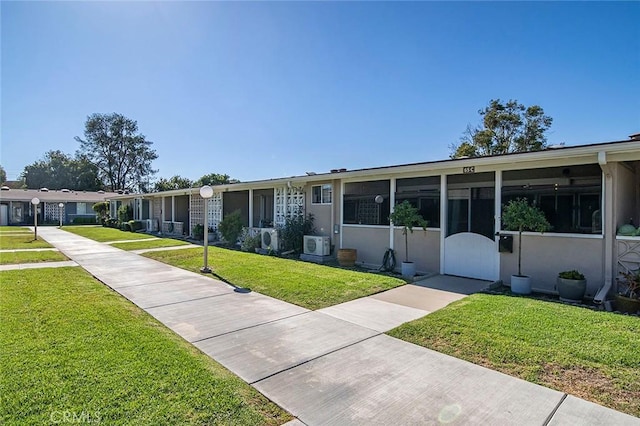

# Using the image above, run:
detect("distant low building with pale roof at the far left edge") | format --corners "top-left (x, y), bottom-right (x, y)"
top-left (0, 186), bottom-right (117, 225)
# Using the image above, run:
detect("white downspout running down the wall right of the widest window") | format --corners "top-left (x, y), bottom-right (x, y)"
top-left (593, 151), bottom-right (615, 304)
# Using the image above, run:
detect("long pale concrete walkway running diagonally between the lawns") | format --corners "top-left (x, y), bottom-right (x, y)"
top-left (31, 228), bottom-right (640, 425)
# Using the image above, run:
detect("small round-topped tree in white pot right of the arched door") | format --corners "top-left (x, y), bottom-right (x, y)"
top-left (502, 198), bottom-right (551, 294)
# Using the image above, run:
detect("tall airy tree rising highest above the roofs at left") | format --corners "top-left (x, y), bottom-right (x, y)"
top-left (75, 113), bottom-right (158, 191)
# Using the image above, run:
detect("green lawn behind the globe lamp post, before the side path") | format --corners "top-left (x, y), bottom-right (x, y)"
top-left (144, 247), bottom-right (405, 309)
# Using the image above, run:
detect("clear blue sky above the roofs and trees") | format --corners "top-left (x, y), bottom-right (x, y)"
top-left (0, 1), bottom-right (640, 181)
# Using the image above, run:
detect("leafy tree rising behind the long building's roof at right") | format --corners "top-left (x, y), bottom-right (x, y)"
top-left (451, 99), bottom-right (553, 158)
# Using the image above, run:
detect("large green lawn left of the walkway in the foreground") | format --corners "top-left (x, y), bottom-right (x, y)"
top-left (0, 268), bottom-right (291, 425)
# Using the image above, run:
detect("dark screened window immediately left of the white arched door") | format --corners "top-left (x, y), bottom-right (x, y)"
top-left (396, 176), bottom-right (440, 228)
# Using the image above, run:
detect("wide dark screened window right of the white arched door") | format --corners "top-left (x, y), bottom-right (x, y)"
top-left (502, 164), bottom-right (602, 234)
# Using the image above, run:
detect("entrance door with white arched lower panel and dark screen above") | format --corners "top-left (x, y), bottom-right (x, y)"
top-left (444, 173), bottom-right (500, 281)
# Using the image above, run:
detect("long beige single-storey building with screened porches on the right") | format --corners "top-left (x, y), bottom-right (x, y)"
top-left (112, 135), bottom-right (640, 297)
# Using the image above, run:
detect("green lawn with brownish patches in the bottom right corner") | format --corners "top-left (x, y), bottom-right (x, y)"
top-left (388, 294), bottom-right (640, 416)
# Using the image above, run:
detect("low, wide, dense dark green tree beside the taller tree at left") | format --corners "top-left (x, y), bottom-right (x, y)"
top-left (22, 150), bottom-right (102, 191)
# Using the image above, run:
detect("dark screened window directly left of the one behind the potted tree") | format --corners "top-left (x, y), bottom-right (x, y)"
top-left (344, 180), bottom-right (391, 225)
